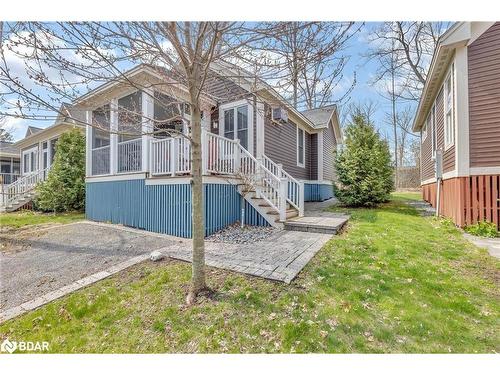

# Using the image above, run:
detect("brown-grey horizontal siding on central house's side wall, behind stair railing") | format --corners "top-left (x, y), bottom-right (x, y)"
top-left (264, 104), bottom-right (311, 180)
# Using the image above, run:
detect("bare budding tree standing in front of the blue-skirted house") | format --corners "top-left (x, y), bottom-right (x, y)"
top-left (0, 22), bottom-right (308, 303)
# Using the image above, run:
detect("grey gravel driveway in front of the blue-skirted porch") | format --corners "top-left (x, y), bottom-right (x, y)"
top-left (0, 222), bottom-right (180, 310)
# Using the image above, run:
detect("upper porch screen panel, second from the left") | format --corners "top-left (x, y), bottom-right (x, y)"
top-left (118, 91), bottom-right (142, 142)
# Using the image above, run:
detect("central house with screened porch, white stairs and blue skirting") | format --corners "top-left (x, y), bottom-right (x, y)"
top-left (78, 65), bottom-right (342, 237)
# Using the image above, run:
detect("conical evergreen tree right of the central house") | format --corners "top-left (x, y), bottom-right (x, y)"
top-left (334, 112), bottom-right (394, 207)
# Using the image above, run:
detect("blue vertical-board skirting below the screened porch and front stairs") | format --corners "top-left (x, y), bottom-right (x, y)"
top-left (85, 180), bottom-right (269, 238)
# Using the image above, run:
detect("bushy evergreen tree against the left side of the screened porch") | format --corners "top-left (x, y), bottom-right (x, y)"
top-left (36, 129), bottom-right (85, 212)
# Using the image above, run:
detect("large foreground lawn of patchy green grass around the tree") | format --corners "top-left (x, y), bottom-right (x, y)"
top-left (0, 194), bottom-right (500, 353)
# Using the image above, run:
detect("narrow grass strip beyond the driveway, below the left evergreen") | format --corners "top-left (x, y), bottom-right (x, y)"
top-left (0, 210), bottom-right (85, 228)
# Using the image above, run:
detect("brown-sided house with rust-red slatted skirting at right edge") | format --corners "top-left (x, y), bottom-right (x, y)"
top-left (413, 22), bottom-right (500, 232)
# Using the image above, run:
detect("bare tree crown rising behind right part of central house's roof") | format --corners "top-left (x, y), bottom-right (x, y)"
top-left (261, 22), bottom-right (363, 109)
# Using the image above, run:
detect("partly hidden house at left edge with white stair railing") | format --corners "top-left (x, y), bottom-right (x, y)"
top-left (0, 103), bottom-right (85, 211)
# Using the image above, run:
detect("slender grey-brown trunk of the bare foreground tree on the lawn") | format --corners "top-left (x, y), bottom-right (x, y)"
top-left (187, 93), bottom-right (206, 304)
